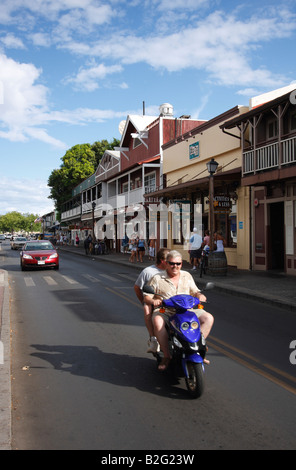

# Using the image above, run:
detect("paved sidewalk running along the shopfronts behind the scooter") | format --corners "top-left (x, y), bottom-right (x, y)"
top-left (59, 245), bottom-right (296, 312)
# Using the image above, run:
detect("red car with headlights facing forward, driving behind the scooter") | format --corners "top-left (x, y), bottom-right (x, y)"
top-left (20, 240), bottom-right (59, 271)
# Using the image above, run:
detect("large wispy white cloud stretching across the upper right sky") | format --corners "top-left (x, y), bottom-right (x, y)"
top-left (80, 8), bottom-right (296, 87)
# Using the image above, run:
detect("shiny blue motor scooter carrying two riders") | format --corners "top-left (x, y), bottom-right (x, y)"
top-left (143, 282), bottom-right (214, 398)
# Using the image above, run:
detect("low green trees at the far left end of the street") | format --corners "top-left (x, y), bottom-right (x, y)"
top-left (0, 211), bottom-right (41, 233)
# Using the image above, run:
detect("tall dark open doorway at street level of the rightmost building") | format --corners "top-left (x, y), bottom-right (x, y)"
top-left (269, 202), bottom-right (285, 269)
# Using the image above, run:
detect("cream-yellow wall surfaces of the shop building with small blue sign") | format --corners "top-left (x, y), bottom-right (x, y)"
top-left (163, 107), bottom-right (250, 269)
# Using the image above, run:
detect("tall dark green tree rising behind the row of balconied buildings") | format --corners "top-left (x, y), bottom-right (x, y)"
top-left (48, 138), bottom-right (120, 212)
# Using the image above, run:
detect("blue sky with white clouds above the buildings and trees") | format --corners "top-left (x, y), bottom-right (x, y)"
top-left (0, 0), bottom-right (296, 215)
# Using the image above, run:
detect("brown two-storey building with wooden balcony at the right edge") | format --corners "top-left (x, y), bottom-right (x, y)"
top-left (222, 85), bottom-right (296, 275)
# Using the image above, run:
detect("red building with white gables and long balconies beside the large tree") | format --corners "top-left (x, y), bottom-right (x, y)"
top-left (62, 103), bottom-right (204, 251)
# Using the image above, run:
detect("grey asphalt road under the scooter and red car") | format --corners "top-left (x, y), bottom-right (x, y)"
top-left (2, 242), bottom-right (296, 451)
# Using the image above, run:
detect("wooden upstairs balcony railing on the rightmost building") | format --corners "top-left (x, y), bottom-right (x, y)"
top-left (243, 137), bottom-right (296, 175)
